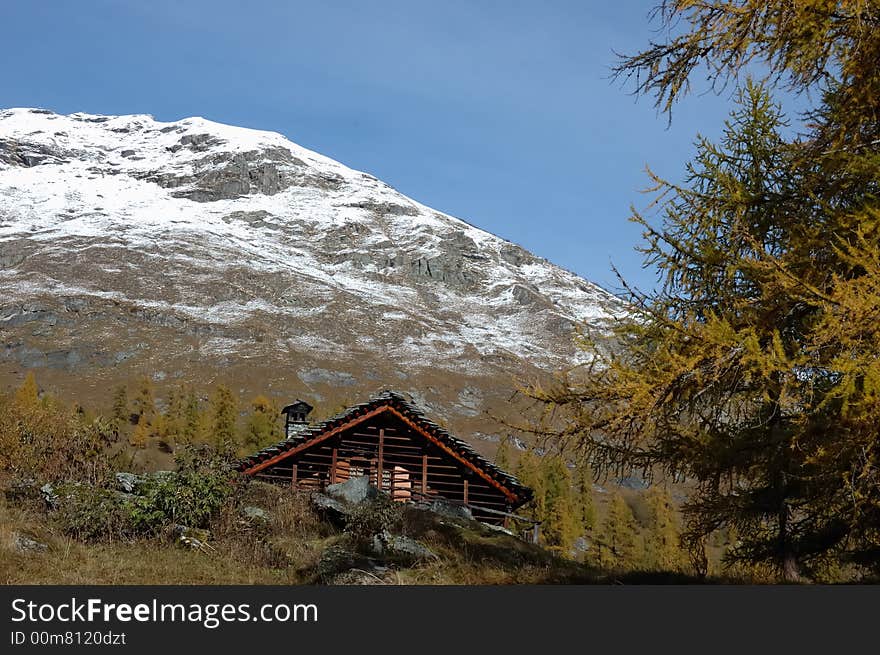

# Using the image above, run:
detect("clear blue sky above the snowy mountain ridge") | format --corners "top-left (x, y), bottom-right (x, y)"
top-left (0, 0), bottom-right (784, 289)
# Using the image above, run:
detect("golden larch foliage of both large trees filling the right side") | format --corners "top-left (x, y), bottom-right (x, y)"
top-left (529, 0), bottom-right (880, 581)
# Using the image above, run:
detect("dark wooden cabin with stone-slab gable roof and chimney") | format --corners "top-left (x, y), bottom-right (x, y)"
top-left (238, 391), bottom-right (532, 524)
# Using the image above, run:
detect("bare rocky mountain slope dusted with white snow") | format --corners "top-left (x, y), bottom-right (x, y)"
top-left (0, 109), bottom-right (619, 438)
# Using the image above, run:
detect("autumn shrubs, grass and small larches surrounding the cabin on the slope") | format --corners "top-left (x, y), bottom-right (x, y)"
top-left (0, 376), bottom-right (755, 584)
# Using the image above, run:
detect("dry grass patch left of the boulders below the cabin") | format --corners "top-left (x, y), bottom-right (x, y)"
top-left (0, 480), bottom-right (329, 585)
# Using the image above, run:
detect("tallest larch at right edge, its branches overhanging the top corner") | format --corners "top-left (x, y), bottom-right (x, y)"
top-left (596, 0), bottom-right (880, 580)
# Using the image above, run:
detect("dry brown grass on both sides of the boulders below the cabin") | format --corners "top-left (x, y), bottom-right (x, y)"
top-left (0, 483), bottom-right (601, 585)
